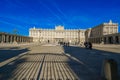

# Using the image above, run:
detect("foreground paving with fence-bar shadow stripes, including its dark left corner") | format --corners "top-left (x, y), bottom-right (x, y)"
top-left (0, 53), bottom-right (79, 80)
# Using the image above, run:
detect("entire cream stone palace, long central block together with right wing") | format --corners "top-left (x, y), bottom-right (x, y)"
top-left (29, 20), bottom-right (120, 44)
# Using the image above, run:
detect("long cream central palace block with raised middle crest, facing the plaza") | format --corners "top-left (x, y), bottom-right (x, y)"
top-left (29, 25), bottom-right (85, 44)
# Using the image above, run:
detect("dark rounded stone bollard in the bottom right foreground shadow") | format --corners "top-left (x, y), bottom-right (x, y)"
top-left (102, 59), bottom-right (118, 80)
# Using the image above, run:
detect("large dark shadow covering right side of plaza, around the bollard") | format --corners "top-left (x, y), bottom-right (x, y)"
top-left (63, 46), bottom-right (120, 80)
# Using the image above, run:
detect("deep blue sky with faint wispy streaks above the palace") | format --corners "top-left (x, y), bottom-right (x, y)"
top-left (0, 0), bottom-right (120, 36)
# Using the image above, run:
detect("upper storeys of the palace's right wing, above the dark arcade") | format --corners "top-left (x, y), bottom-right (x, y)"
top-left (90, 20), bottom-right (118, 37)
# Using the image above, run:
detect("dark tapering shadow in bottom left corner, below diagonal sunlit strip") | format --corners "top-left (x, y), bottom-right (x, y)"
top-left (0, 58), bottom-right (27, 80)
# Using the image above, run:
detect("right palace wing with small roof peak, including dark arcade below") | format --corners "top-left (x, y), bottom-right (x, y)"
top-left (85, 20), bottom-right (120, 44)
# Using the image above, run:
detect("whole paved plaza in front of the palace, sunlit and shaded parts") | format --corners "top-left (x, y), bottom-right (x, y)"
top-left (0, 44), bottom-right (120, 80)
